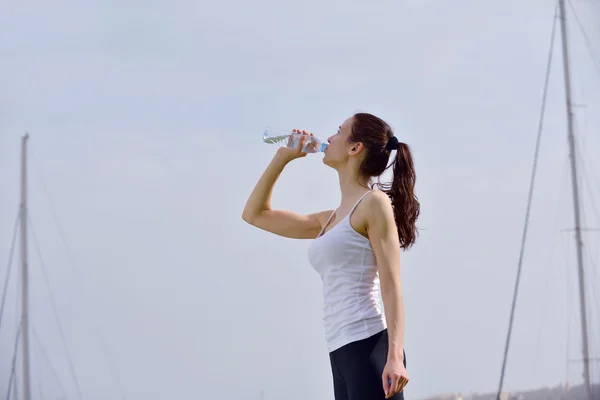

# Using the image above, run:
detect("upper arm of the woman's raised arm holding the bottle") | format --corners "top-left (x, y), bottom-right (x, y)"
top-left (241, 210), bottom-right (333, 239)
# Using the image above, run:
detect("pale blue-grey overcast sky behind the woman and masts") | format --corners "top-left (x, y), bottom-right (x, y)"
top-left (0, 0), bottom-right (600, 400)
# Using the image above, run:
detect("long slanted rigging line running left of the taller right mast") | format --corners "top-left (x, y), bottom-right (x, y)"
top-left (496, 3), bottom-right (558, 400)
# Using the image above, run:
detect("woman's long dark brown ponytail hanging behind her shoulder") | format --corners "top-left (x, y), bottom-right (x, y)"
top-left (385, 142), bottom-right (421, 249)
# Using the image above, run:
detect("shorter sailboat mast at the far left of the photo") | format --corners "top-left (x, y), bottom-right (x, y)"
top-left (20, 134), bottom-right (31, 400)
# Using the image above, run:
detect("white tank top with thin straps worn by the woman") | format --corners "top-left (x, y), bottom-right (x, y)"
top-left (308, 191), bottom-right (386, 352)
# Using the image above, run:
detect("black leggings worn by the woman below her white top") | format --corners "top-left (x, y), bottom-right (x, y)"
top-left (329, 329), bottom-right (406, 400)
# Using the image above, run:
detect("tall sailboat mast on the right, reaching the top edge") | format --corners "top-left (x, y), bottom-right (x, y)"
top-left (558, 0), bottom-right (592, 400)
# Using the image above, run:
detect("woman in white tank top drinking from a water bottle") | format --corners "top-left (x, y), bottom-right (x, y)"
top-left (242, 113), bottom-right (420, 400)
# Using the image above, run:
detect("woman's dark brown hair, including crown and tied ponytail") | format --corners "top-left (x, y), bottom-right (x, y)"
top-left (349, 113), bottom-right (420, 249)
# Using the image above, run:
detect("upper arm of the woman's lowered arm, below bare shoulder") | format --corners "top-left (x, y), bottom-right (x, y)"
top-left (366, 191), bottom-right (400, 290)
